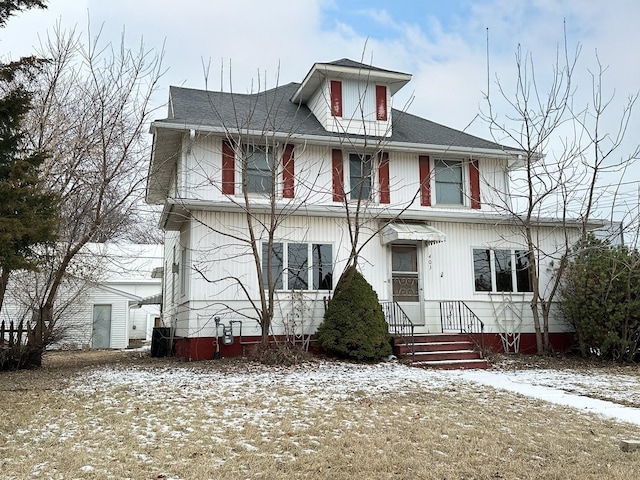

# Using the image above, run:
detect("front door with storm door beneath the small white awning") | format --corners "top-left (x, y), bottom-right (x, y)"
top-left (391, 245), bottom-right (424, 325)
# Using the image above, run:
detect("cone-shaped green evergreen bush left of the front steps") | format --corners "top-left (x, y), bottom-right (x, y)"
top-left (316, 266), bottom-right (392, 361)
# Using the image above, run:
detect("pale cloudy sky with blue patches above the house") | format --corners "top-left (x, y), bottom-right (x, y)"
top-left (0, 0), bottom-right (640, 219)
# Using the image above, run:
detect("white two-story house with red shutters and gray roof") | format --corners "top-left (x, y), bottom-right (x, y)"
top-left (146, 59), bottom-right (576, 360)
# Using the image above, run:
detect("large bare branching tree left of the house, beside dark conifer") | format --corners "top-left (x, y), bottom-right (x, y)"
top-left (20, 26), bottom-right (162, 348)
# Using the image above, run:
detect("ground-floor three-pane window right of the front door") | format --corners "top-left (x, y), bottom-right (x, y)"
top-left (473, 249), bottom-right (531, 292)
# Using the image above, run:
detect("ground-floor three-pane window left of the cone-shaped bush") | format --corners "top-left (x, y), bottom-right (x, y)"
top-left (262, 242), bottom-right (333, 290)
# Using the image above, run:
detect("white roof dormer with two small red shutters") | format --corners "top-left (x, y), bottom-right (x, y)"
top-left (291, 58), bottom-right (411, 137)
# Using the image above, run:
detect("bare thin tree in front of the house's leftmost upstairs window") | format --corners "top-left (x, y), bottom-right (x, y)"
top-left (172, 66), bottom-right (315, 345)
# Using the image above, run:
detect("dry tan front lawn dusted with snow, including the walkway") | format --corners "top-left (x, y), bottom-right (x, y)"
top-left (0, 348), bottom-right (640, 480)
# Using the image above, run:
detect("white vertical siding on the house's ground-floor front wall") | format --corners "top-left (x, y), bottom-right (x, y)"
top-left (176, 206), bottom-right (576, 336)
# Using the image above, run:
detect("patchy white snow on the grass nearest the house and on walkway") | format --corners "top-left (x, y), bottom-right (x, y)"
top-left (67, 362), bottom-right (640, 428)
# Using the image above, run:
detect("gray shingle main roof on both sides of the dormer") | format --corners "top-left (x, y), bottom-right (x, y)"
top-left (158, 81), bottom-right (505, 150)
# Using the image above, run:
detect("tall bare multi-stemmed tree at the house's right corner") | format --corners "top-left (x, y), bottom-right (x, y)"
top-left (483, 34), bottom-right (638, 354)
